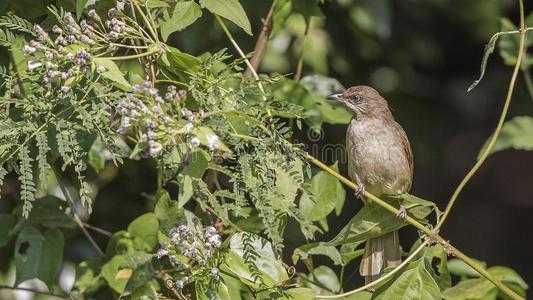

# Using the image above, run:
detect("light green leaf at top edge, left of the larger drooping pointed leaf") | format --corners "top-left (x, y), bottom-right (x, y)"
top-left (160, 1), bottom-right (202, 42)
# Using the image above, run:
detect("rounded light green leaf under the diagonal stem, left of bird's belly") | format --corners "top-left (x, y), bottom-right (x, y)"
top-left (300, 163), bottom-right (346, 221)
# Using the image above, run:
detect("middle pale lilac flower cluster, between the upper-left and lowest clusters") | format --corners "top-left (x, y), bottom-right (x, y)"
top-left (117, 81), bottom-right (220, 157)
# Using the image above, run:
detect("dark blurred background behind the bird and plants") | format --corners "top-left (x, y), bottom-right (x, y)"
top-left (0, 0), bottom-right (533, 294)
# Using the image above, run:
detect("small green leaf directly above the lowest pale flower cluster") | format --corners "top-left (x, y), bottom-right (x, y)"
top-left (154, 189), bottom-right (186, 234)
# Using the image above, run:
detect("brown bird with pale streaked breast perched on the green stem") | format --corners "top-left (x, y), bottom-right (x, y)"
top-left (328, 86), bottom-right (413, 283)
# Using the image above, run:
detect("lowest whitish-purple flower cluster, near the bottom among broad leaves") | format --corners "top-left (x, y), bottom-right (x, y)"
top-left (155, 219), bottom-right (222, 289)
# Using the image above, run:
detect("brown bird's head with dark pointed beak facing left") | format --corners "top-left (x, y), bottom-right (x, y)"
top-left (327, 85), bottom-right (391, 118)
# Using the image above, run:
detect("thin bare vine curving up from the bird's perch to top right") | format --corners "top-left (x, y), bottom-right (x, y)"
top-left (435, 0), bottom-right (526, 232)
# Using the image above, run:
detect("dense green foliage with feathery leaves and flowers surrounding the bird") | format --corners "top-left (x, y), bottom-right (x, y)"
top-left (0, 0), bottom-right (533, 299)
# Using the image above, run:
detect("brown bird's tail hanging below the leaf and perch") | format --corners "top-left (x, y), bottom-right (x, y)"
top-left (359, 231), bottom-right (402, 283)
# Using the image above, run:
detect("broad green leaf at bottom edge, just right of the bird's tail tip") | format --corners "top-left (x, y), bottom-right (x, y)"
top-left (372, 258), bottom-right (442, 300)
